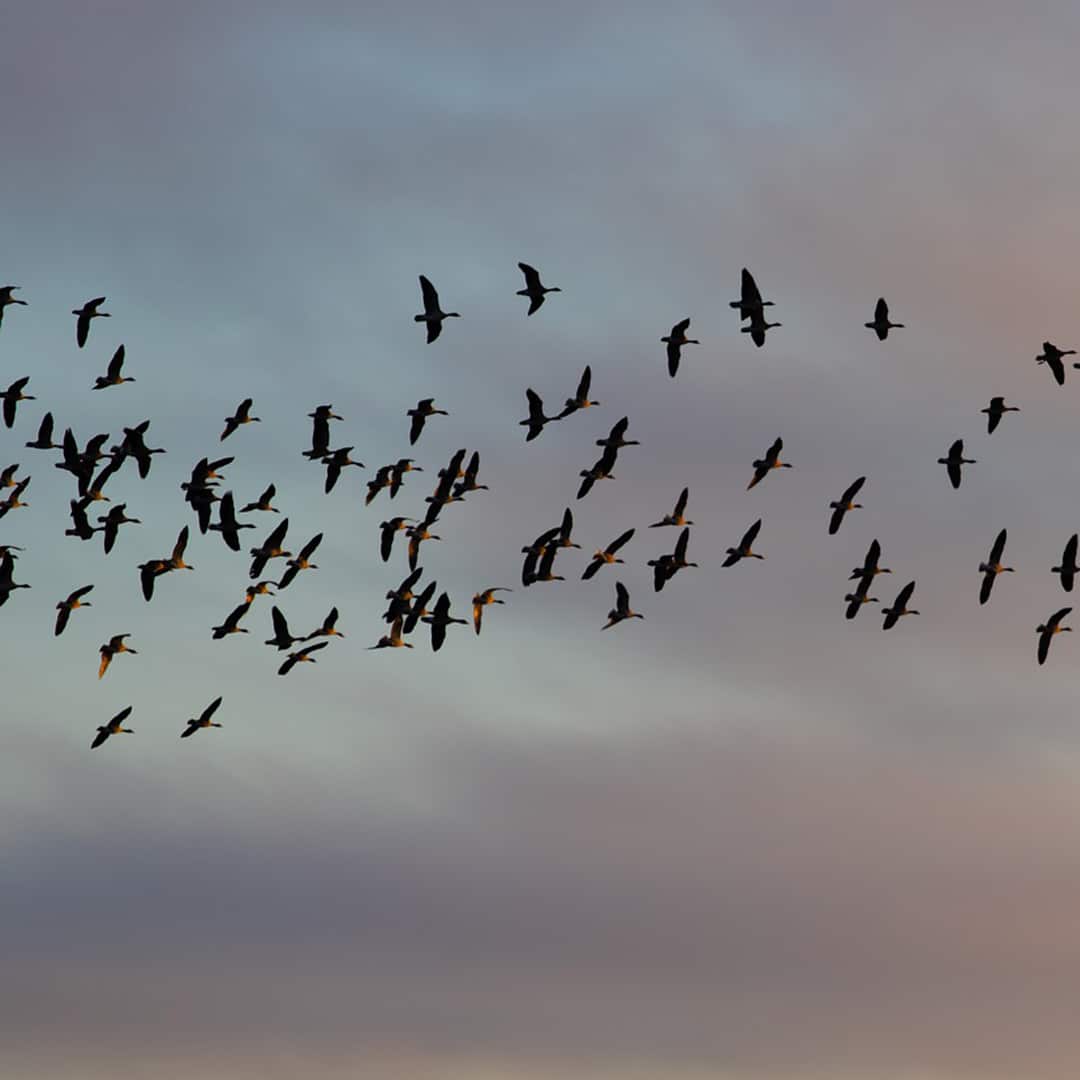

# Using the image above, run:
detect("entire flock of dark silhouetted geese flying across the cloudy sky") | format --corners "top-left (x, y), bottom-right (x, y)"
top-left (0, 262), bottom-right (1080, 748)
